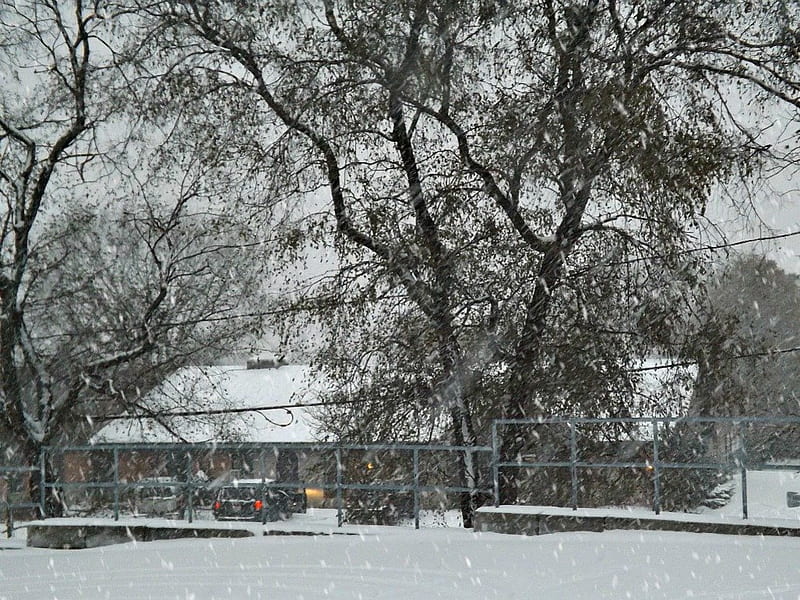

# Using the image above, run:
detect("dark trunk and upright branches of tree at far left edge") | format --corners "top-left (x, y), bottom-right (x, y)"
top-left (0, 2), bottom-right (110, 482)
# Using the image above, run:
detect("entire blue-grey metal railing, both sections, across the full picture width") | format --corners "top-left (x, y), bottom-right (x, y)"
top-left (7, 417), bottom-right (800, 528)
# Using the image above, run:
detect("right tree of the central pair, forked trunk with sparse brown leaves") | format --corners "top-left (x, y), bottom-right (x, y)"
top-left (350, 1), bottom-right (800, 501)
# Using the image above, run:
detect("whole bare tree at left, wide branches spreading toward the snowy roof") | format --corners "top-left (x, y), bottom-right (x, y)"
top-left (0, 0), bottom-right (268, 512)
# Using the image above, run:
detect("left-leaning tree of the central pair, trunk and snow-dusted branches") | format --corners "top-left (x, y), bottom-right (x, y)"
top-left (123, 2), bottom-right (494, 522)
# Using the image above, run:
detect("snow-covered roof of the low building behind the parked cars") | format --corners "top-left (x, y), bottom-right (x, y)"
top-left (92, 365), bottom-right (329, 443)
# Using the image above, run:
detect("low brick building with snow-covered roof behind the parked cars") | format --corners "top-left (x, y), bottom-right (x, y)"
top-left (58, 360), bottom-right (329, 504)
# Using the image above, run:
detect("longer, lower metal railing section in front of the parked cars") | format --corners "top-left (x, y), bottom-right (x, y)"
top-left (40, 443), bottom-right (492, 528)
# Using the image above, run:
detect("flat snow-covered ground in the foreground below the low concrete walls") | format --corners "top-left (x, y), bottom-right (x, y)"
top-left (0, 527), bottom-right (800, 600)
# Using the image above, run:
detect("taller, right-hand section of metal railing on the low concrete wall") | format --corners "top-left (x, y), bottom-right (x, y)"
top-left (492, 417), bottom-right (800, 519)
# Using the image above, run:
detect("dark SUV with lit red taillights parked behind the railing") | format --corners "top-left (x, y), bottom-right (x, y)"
top-left (213, 480), bottom-right (306, 521)
